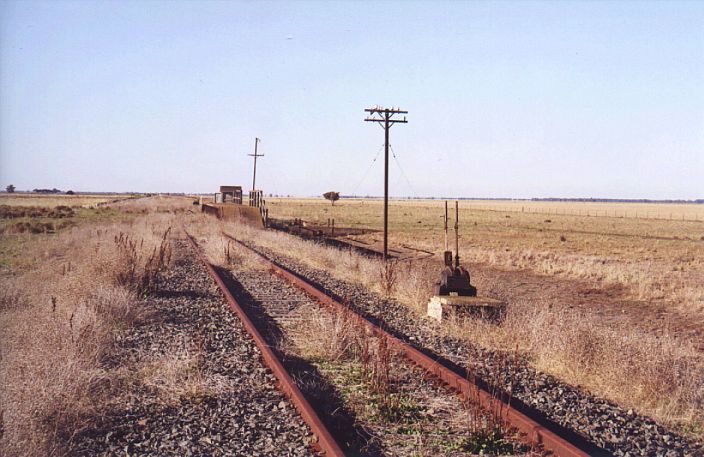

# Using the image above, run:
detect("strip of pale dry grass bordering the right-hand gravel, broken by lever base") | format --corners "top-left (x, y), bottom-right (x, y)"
top-left (216, 217), bottom-right (704, 436)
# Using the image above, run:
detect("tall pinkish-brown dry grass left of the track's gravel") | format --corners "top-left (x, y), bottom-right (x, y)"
top-left (0, 214), bottom-right (174, 456)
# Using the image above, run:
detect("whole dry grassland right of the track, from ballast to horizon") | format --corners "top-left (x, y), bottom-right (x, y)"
top-left (264, 198), bottom-right (704, 438)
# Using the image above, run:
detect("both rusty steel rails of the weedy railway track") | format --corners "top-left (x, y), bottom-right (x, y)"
top-left (182, 228), bottom-right (609, 456)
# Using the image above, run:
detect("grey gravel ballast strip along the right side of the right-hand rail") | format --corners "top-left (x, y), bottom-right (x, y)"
top-left (239, 242), bottom-right (704, 457)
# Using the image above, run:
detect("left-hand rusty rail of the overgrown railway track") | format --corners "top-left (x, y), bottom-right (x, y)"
top-left (184, 232), bottom-right (345, 457)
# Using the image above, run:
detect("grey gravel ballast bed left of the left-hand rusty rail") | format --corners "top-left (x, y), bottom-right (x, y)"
top-left (73, 240), bottom-right (314, 456)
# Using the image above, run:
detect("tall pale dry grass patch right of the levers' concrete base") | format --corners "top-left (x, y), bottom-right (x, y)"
top-left (454, 302), bottom-right (704, 437)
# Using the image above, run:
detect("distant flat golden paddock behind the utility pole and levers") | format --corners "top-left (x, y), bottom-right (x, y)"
top-left (267, 199), bottom-right (704, 316)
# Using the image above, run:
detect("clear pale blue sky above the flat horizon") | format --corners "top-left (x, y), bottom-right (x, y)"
top-left (0, 1), bottom-right (704, 198)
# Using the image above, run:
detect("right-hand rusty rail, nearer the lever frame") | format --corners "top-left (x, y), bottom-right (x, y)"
top-left (222, 232), bottom-right (590, 457)
